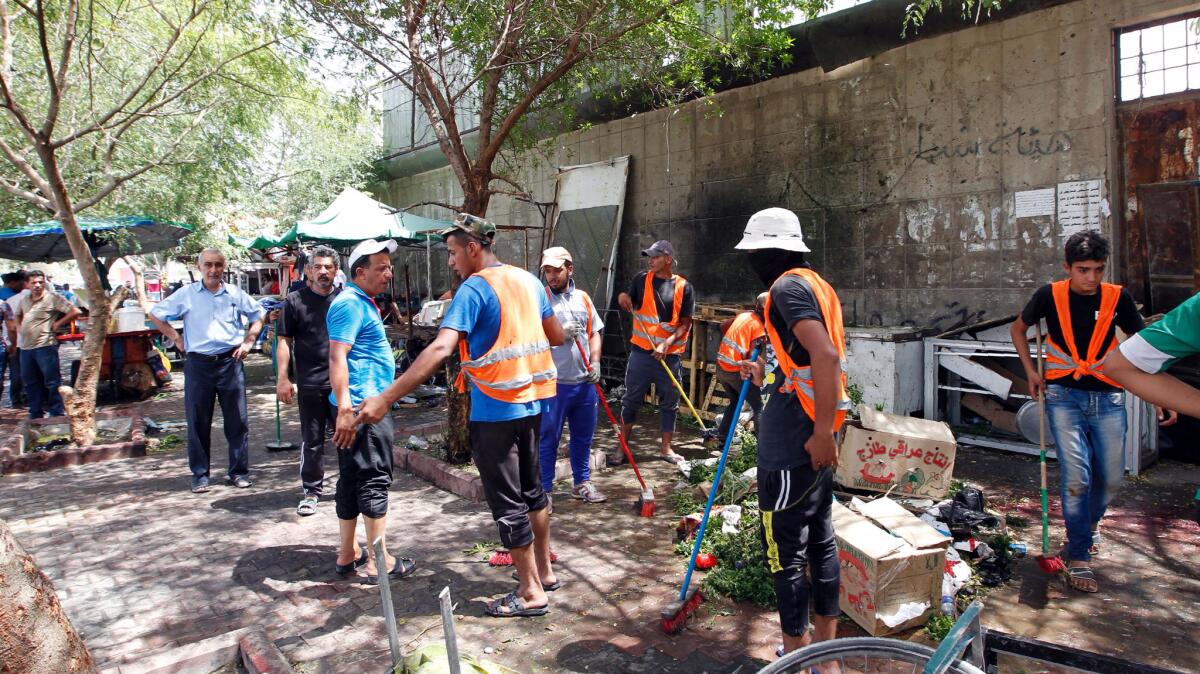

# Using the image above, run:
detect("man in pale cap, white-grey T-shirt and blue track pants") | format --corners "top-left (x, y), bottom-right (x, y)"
top-left (539, 246), bottom-right (607, 504)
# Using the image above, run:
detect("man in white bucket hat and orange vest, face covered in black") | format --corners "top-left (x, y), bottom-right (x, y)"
top-left (737, 209), bottom-right (850, 655)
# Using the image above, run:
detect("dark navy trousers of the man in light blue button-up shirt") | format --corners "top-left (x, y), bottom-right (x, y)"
top-left (184, 354), bottom-right (250, 485)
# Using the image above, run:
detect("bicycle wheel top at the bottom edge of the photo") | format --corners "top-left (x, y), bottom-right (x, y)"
top-left (758, 637), bottom-right (983, 674)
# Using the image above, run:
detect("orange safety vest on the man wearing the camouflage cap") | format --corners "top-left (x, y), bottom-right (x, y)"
top-left (457, 265), bottom-right (558, 403)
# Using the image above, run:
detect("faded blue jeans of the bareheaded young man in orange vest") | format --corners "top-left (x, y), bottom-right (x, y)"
top-left (1046, 384), bottom-right (1126, 561)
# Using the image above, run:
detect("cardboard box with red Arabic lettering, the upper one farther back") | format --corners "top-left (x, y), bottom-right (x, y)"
top-left (834, 405), bottom-right (958, 499)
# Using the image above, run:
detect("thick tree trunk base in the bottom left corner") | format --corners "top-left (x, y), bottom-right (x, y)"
top-left (0, 519), bottom-right (97, 674)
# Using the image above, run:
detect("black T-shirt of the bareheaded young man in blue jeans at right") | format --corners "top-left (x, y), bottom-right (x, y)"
top-left (1021, 284), bottom-right (1146, 391)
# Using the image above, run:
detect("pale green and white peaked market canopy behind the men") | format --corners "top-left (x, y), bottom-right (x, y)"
top-left (278, 187), bottom-right (454, 245)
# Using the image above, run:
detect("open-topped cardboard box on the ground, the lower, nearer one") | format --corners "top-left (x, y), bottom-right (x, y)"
top-left (833, 497), bottom-right (950, 636)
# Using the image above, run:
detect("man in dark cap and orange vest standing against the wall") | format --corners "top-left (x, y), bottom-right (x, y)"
top-left (610, 241), bottom-right (696, 465)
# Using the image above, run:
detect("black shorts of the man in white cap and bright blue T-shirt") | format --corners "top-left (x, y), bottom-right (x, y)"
top-left (330, 405), bottom-right (395, 519)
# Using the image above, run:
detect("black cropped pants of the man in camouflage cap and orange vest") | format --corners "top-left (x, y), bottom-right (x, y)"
top-left (470, 414), bottom-right (550, 549)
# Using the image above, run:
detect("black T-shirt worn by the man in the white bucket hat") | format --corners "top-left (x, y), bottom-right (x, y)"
top-left (758, 269), bottom-right (824, 470)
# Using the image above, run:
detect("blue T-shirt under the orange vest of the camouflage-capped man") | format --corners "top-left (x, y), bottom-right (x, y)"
top-left (442, 263), bottom-right (554, 421)
